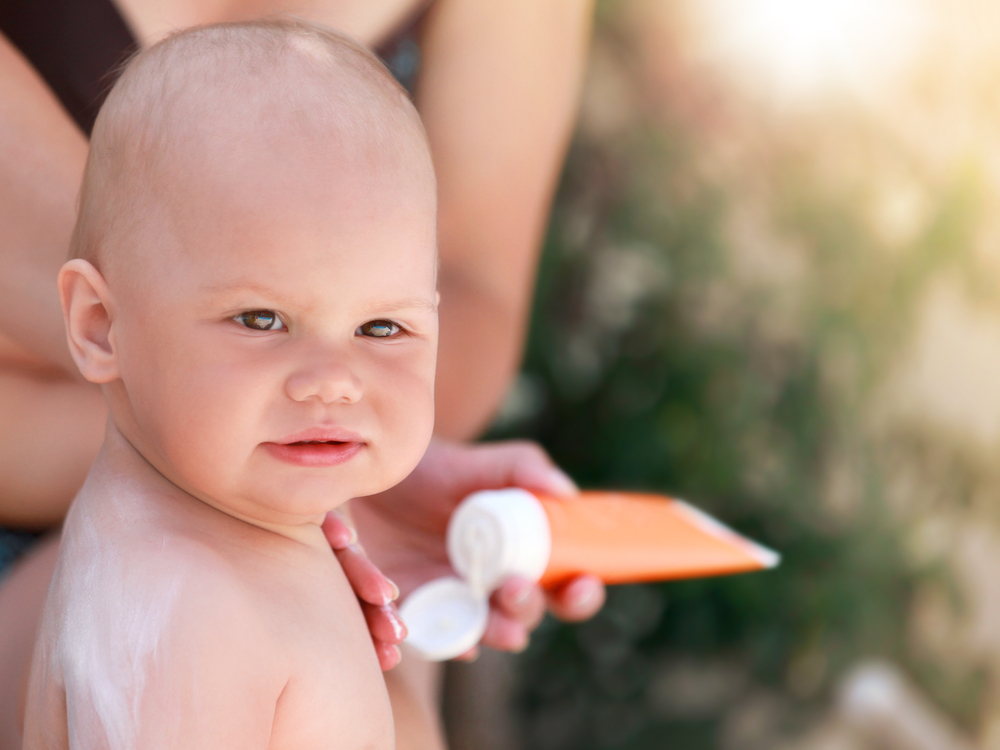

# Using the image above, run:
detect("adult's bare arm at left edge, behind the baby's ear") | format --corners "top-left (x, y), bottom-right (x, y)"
top-left (0, 35), bottom-right (105, 528)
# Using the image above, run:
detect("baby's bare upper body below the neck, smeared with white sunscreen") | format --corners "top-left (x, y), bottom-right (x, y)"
top-left (24, 477), bottom-right (393, 750)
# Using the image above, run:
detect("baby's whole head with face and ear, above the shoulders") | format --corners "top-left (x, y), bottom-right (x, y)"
top-left (60, 20), bottom-right (437, 524)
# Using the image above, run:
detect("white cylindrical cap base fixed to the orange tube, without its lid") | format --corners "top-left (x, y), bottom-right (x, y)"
top-left (448, 487), bottom-right (552, 594)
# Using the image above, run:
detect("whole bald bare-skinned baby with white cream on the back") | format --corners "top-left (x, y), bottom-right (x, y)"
top-left (24, 20), bottom-right (437, 750)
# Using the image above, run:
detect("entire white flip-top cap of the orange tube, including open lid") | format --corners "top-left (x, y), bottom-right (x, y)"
top-left (399, 488), bottom-right (552, 661)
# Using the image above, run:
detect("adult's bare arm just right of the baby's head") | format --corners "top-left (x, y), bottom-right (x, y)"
top-left (416, 0), bottom-right (591, 439)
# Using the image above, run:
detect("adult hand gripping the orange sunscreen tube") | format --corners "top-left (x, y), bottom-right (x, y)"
top-left (345, 441), bottom-right (604, 664)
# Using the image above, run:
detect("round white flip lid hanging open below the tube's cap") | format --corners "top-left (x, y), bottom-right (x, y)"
top-left (399, 577), bottom-right (490, 661)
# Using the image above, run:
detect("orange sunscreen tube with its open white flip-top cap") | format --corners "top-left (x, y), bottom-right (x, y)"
top-left (401, 488), bottom-right (780, 661)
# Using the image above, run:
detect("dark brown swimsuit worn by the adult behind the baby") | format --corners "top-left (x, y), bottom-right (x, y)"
top-left (0, 0), bottom-right (429, 581)
